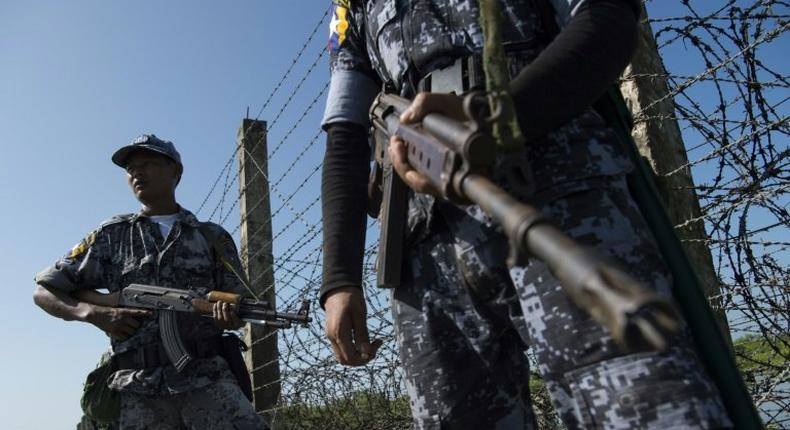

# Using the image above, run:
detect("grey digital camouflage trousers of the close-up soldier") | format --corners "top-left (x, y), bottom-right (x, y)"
top-left (392, 176), bottom-right (731, 429)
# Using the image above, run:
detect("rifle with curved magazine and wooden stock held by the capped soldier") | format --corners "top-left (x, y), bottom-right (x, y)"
top-left (75, 284), bottom-right (312, 372)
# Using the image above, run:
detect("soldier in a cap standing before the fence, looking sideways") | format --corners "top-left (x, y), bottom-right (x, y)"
top-left (34, 135), bottom-right (266, 430)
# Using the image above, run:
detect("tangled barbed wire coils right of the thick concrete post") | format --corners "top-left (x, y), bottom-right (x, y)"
top-left (656, 1), bottom-right (790, 428)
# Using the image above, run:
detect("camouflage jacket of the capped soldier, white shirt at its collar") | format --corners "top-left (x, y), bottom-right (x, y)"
top-left (35, 209), bottom-right (245, 395)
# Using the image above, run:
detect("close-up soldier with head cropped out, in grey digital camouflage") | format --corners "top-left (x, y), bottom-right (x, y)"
top-left (321, 0), bottom-right (731, 429)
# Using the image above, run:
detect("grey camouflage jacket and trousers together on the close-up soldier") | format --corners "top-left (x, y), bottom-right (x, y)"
top-left (325, 0), bottom-right (731, 429)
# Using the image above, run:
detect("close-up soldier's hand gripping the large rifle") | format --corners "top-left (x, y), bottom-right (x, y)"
top-left (389, 93), bottom-right (467, 197)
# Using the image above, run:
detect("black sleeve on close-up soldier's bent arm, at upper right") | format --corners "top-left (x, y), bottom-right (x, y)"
top-left (510, 0), bottom-right (638, 139)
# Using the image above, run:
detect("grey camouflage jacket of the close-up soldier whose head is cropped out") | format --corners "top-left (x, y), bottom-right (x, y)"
top-left (322, 0), bottom-right (632, 241)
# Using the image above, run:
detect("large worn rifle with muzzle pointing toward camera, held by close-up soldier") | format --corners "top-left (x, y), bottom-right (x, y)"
top-left (370, 92), bottom-right (680, 350)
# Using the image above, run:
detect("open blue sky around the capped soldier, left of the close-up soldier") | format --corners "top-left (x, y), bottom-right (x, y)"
top-left (0, 0), bottom-right (788, 429)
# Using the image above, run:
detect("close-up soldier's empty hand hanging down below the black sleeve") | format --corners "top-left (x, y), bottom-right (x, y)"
top-left (324, 287), bottom-right (382, 366)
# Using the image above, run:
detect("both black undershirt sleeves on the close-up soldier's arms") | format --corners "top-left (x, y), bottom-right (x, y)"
top-left (319, 0), bottom-right (637, 306)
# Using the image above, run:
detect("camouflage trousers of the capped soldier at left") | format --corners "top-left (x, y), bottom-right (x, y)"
top-left (119, 381), bottom-right (269, 430)
